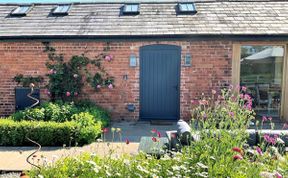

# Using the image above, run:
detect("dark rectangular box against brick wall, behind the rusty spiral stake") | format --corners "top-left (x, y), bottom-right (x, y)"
top-left (15, 87), bottom-right (40, 111)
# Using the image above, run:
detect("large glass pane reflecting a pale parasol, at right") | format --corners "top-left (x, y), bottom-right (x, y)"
top-left (240, 46), bottom-right (284, 117)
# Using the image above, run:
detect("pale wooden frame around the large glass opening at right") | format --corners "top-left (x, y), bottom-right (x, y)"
top-left (231, 42), bottom-right (288, 122)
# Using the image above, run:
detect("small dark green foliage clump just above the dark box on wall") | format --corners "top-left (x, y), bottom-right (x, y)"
top-left (13, 74), bottom-right (44, 87)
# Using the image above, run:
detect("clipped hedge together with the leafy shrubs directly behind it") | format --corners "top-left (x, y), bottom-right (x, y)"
top-left (0, 102), bottom-right (109, 146)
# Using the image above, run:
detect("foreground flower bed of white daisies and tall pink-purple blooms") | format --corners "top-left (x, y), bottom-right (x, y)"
top-left (29, 88), bottom-right (288, 178)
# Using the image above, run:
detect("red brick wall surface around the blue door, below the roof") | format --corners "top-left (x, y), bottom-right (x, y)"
top-left (0, 40), bottom-right (232, 120)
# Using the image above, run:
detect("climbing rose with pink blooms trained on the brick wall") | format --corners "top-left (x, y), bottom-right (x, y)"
top-left (43, 42), bottom-right (114, 101)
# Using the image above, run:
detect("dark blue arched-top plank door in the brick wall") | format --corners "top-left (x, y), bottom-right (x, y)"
top-left (140, 45), bottom-right (181, 120)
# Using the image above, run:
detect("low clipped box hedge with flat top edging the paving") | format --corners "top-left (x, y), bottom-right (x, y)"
top-left (0, 119), bottom-right (102, 146)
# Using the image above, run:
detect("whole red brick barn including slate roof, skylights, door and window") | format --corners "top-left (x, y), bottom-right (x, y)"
top-left (0, 0), bottom-right (288, 120)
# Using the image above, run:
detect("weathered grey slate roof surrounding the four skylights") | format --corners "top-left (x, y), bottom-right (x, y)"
top-left (0, 0), bottom-right (288, 38)
